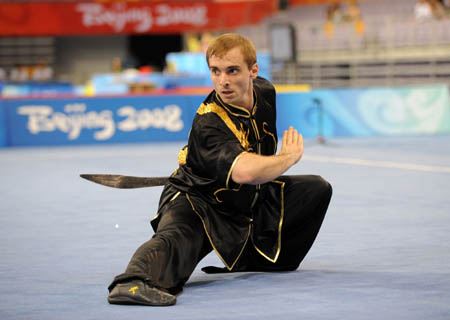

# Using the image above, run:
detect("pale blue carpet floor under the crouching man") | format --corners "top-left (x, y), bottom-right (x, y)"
top-left (0, 136), bottom-right (450, 320)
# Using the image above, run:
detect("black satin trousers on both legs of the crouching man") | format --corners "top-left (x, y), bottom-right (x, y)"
top-left (109, 175), bottom-right (332, 294)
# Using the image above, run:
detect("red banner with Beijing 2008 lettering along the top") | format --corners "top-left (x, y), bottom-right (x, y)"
top-left (0, 0), bottom-right (277, 36)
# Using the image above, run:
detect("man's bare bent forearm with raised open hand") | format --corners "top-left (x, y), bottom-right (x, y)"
top-left (231, 127), bottom-right (303, 184)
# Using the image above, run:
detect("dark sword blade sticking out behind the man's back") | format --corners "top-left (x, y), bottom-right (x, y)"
top-left (80, 174), bottom-right (169, 189)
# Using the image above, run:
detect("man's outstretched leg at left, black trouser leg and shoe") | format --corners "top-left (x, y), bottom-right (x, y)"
top-left (108, 194), bottom-right (212, 305)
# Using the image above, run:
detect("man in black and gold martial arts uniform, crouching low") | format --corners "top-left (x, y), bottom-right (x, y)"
top-left (108, 34), bottom-right (331, 305)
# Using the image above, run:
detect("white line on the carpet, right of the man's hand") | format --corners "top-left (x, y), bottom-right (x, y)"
top-left (302, 155), bottom-right (450, 173)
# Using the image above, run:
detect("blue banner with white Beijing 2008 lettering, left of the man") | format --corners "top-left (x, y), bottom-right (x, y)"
top-left (3, 96), bottom-right (203, 146)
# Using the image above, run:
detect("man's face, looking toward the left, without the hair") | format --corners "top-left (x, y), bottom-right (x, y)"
top-left (209, 47), bottom-right (258, 110)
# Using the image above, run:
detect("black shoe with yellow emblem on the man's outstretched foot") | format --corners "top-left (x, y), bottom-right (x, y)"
top-left (108, 280), bottom-right (177, 306)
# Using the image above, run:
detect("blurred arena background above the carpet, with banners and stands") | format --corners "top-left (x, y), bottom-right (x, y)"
top-left (0, 0), bottom-right (450, 146)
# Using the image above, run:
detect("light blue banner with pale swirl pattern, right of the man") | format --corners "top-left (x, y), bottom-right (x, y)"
top-left (277, 85), bottom-right (450, 137)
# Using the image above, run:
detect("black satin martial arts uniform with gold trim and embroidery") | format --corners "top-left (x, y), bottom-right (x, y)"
top-left (109, 77), bottom-right (332, 294)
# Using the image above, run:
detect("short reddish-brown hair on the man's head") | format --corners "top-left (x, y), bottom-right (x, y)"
top-left (206, 33), bottom-right (256, 69)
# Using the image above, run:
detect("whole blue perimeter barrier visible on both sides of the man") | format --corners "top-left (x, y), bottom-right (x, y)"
top-left (0, 85), bottom-right (450, 147)
